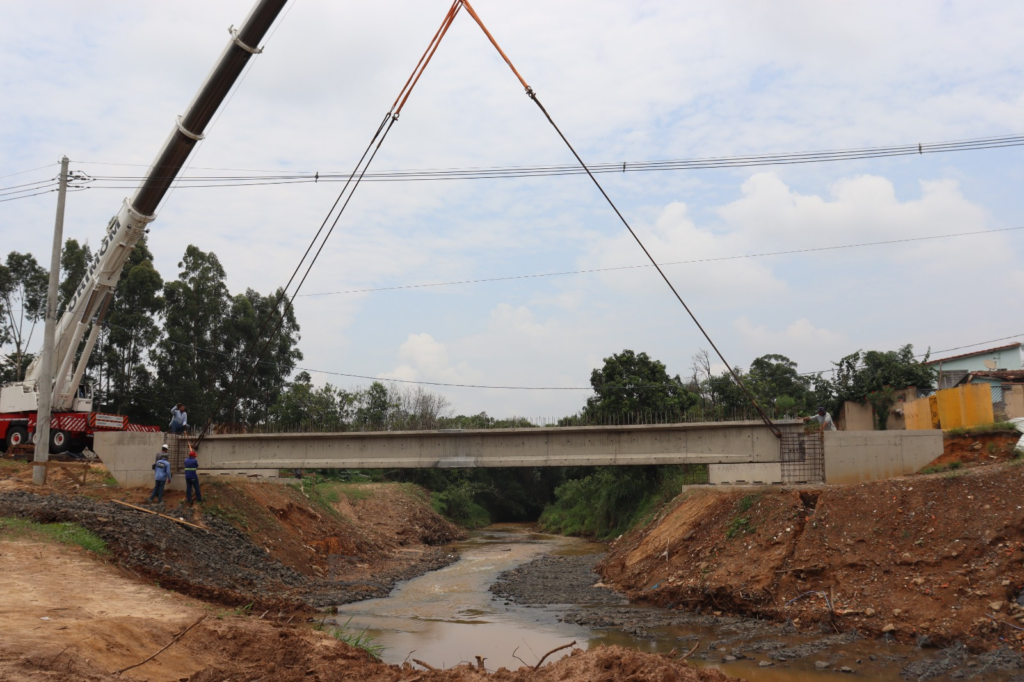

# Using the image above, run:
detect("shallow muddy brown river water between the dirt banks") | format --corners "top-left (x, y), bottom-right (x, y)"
top-left (329, 524), bottom-right (1020, 682)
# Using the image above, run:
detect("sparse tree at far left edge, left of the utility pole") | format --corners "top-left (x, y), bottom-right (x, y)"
top-left (0, 251), bottom-right (48, 381)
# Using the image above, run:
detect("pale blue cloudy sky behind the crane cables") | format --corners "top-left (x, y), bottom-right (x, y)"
top-left (0, 0), bottom-right (1024, 417)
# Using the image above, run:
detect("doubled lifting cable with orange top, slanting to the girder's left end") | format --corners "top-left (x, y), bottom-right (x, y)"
top-left (194, 0), bottom-right (462, 449)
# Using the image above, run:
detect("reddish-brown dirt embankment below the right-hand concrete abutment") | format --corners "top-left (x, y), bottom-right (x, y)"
top-left (599, 464), bottom-right (1024, 650)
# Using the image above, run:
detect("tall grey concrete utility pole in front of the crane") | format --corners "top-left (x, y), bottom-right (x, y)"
top-left (32, 157), bottom-right (68, 485)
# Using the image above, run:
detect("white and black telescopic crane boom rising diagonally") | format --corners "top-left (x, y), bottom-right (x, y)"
top-left (0, 0), bottom-right (288, 414)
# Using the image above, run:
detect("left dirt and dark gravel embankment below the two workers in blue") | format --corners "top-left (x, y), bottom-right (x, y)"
top-left (0, 461), bottom-right (464, 611)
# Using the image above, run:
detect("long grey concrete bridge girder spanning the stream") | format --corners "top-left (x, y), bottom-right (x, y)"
top-left (190, 422), bottom-right (802, 470)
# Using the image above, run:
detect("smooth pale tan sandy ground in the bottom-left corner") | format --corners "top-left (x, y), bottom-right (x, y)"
top-left (0, 541), bottom-right (208, 680)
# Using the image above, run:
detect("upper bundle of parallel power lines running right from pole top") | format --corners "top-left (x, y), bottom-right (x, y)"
top-left (66, 130), bottom-right (1024, 188)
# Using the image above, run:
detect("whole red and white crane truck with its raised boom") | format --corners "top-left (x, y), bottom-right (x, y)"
top-left (0, 0), bottom-right (288, 454)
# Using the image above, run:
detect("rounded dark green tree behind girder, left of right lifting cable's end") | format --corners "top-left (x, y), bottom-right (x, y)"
top-left (584, 349), bottom-right (696, 423)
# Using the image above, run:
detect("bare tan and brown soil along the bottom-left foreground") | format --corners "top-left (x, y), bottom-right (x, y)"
top-left (0, 535), bottom-right (728, 682)
